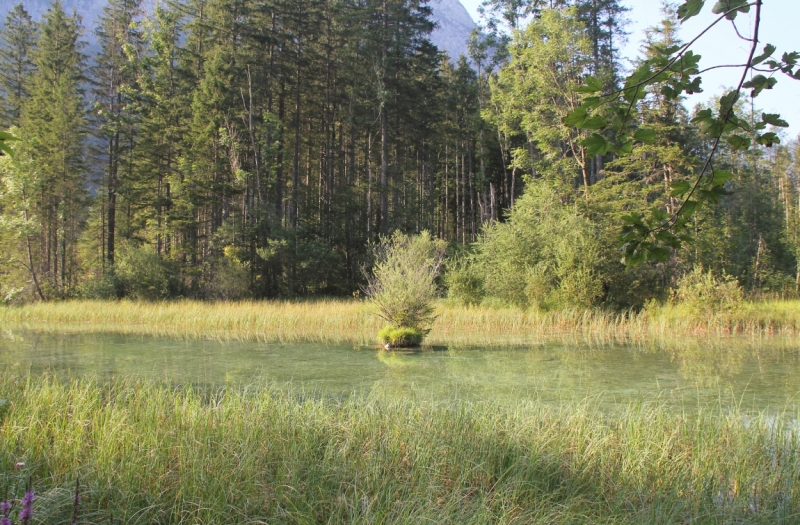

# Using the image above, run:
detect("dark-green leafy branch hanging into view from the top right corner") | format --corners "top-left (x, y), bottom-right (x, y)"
top-left (563, 0), bottom-right (800, 265)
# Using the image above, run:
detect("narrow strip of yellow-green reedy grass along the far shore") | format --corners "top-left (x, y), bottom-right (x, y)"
top-left (0, 300), bottom-right (800, 345)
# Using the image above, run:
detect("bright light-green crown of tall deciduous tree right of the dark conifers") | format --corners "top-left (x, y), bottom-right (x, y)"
top-left (483, 9), bottom-right (605, 185)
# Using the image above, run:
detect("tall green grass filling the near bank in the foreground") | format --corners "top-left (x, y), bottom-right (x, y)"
top-left (0, 377), bottom-right (800, 524)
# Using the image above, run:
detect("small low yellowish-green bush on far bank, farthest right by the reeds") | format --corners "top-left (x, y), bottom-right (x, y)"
top-left (672, 266), bottom-right (744, 314)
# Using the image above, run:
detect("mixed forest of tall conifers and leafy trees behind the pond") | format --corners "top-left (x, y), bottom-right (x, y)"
top-left (0, 0), bottom-right (800, 310)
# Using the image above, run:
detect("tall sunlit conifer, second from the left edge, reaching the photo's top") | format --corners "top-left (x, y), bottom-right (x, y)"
top-left (19, 0), bottom-right (86, 297)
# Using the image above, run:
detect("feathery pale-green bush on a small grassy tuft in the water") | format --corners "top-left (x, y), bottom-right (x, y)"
top-left (363, 231), bottom-right (445, 344)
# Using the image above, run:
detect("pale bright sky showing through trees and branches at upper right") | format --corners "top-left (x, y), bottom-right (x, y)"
top-left (461, 0), bottom-right (800, 142)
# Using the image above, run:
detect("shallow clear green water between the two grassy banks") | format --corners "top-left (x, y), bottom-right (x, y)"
top-left (0, 330), bottom-right (800, 413)
